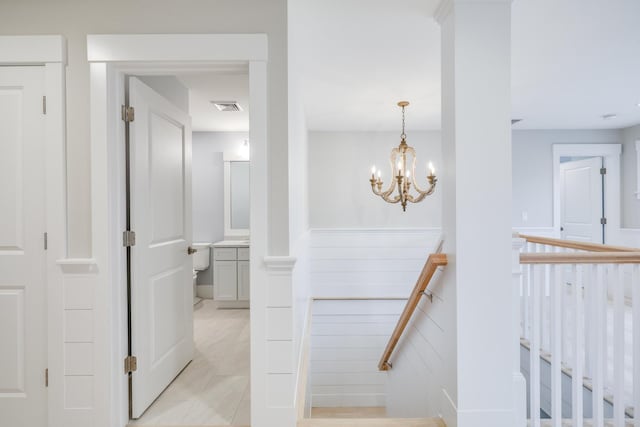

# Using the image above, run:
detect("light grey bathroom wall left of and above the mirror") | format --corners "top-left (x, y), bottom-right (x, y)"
top-left (191, 132), bottom-right (249, 292)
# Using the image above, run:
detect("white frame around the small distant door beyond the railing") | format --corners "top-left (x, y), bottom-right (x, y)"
top-left (552, 144), bottom-right (622, 245)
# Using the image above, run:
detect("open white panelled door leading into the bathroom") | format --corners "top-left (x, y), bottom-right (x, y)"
top-left (129, 77), bottom-right (194, 418)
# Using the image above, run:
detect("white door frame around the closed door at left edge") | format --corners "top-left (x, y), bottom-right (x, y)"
top-left (0, 36), bottom-right (67, 426)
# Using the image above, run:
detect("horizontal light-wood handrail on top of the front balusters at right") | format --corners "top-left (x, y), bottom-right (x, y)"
top-left (520, 251), bottom-right (640, 264)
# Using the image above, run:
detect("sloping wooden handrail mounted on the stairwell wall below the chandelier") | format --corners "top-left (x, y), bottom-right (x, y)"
top-left (378, 253), bottom-right (447, 371)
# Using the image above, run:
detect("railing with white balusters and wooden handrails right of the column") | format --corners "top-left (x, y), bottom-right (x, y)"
top-left (515, 235), bottom-right (640, 427)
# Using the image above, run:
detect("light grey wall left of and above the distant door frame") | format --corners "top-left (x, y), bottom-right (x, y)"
top-left (511, 130), bottom-right (621, 228)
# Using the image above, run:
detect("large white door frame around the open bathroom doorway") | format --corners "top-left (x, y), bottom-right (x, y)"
top-left (87, 34), bottom-right (268, 427)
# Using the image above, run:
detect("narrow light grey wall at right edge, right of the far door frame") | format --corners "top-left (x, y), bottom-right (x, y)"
top-left (621, 125), bottom-right (640, 229)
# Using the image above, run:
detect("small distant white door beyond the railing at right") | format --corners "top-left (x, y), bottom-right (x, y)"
top-left (560, 157), bottom-right (604, 243)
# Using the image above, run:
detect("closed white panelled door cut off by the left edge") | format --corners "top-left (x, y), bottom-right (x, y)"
top-left (0, 67), bottom-right (47, 427)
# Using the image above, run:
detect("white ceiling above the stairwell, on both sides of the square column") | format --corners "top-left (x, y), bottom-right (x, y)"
top-left (289, 0), bottom-right (640, 131)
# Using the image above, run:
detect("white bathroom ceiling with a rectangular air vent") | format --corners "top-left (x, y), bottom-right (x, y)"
top-left (176, 71), bottom-right (249, 132)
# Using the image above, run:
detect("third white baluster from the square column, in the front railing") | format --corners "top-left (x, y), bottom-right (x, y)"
top-left (571, 265), bottom-right (584, 427)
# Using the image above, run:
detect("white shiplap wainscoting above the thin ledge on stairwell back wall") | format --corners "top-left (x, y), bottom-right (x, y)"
top-left (310, 228), bottom-right (440, 298)
